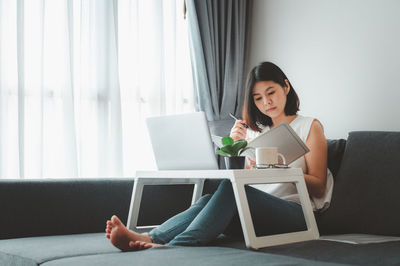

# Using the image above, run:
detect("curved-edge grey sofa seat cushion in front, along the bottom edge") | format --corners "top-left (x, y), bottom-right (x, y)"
top-left (39, 246), bottom-right (337, 266)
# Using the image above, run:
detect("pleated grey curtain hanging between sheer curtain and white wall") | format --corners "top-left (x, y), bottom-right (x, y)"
top-left (186, 0), bottom-right (252, 121)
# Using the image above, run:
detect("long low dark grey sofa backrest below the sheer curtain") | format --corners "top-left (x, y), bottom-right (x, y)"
top-left (0, 178), bottom-right (193, 239)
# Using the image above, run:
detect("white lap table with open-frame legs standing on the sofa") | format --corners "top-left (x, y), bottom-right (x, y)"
top-left (127, 168), bottom-right (319, 249)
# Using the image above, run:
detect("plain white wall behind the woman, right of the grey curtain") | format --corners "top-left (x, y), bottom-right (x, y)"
top-left (248, 0), bottom-right (400, 138)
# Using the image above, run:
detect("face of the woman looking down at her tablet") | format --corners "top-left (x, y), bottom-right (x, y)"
top-left (253, 80), bottom-right (290, 119)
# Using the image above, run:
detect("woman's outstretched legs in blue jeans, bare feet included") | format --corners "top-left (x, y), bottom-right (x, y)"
top-left (106, 180), bottom-right (306, 251)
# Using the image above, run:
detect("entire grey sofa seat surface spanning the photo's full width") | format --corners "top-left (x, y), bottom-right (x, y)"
top-left (0, 233), bottom-right (400, 266)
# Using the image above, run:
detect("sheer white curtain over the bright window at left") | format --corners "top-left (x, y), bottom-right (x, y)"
top-left (0, 0), bottom-right (194, 178)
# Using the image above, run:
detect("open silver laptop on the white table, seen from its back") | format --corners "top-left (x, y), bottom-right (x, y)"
top-left (146, 112), bottom-right (218, 170)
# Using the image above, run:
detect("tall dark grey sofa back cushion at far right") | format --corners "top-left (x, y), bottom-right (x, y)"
top-left (317, 131), bottom-right (400, 236)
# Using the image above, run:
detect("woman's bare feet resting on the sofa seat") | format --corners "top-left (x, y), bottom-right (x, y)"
top-left (106, 215), bottom-right (153, 251)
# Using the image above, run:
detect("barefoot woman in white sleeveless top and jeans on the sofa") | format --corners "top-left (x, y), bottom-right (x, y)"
top-left (106, 62), bottom-right (333, 251)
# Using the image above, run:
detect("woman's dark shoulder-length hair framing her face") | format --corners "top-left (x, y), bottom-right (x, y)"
top-left (242, 62), bottom-right (300, 131)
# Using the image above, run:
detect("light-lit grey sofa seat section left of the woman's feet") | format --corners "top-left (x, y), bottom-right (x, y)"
top-left (0, 233), bottom-right (120, 266)
